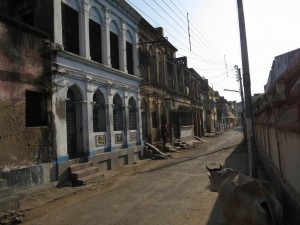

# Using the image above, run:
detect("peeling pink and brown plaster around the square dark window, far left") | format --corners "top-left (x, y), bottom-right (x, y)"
top-left (0, 17), bottom-right (51, 171)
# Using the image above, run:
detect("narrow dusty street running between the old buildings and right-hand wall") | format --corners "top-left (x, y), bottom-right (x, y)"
top-left (23, 129), bottom-right (247, 225)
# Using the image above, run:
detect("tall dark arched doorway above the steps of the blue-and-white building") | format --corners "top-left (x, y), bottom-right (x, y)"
top-left (66, 86), bottom-right (83, 159)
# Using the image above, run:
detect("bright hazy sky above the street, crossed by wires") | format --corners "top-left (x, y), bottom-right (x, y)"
top-left (126, 0), bottom-right (300, 101)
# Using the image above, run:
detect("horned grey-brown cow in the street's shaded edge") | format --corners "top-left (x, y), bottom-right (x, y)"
top-left (206, 165), bottom-right (283, 225)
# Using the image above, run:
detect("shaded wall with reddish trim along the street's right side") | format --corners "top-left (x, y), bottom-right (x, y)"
top-left (255, 106), bottom-right (300, 193)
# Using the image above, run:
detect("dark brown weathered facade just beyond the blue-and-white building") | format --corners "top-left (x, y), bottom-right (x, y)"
top-left (139, 20), bottom-right (203, 146)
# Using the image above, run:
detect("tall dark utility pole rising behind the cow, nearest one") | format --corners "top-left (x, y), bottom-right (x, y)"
top-left (237, 0), bottom-right (257, 178)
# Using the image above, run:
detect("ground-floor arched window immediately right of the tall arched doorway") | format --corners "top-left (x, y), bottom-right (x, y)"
top-left (93, 90), bottom-right (106, 132)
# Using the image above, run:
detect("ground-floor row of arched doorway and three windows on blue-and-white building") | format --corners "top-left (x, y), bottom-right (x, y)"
top-left (65, 84), bottom-right (140, 158)
